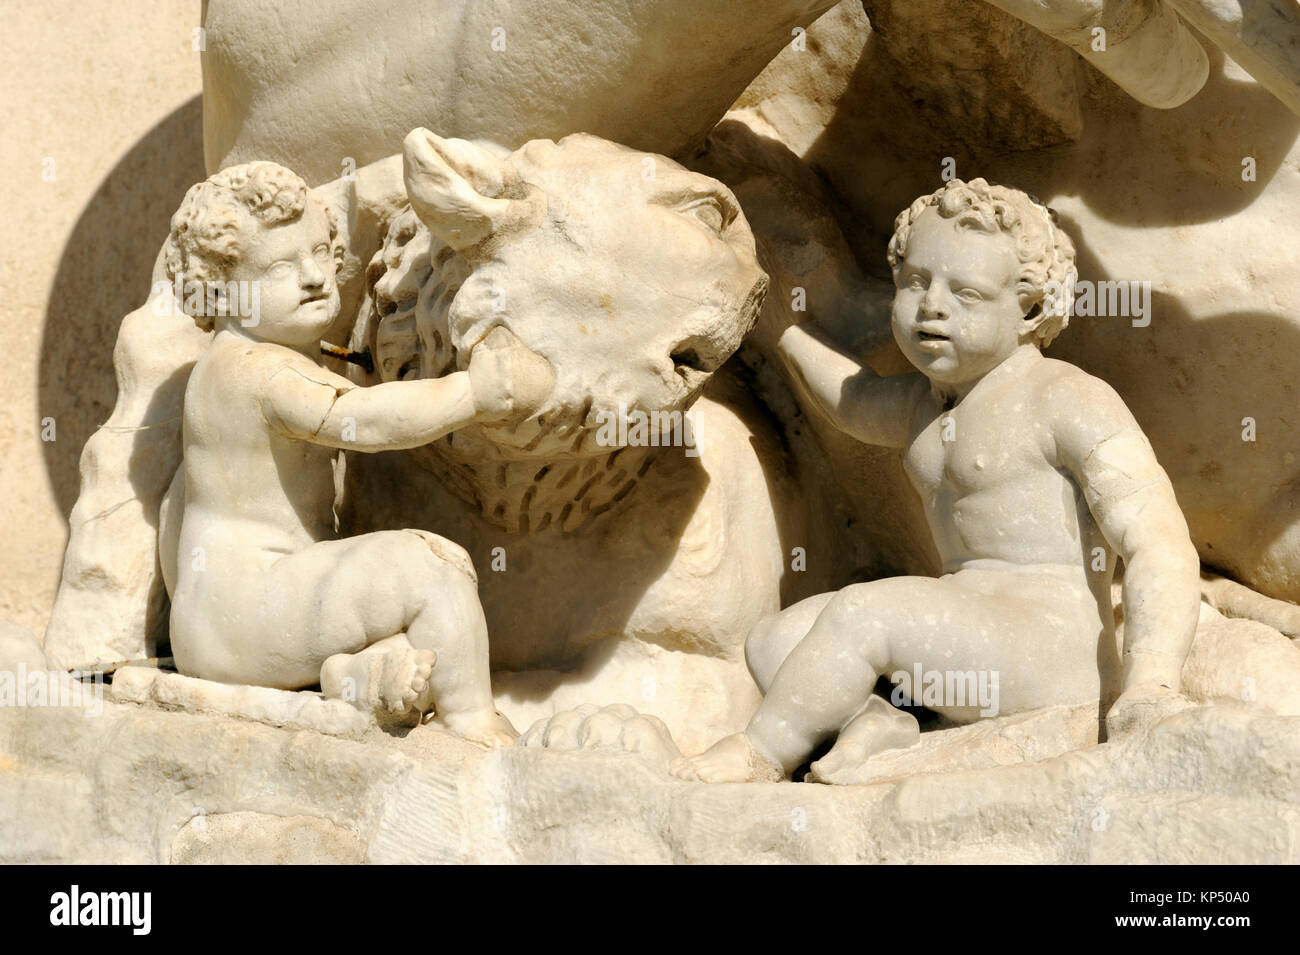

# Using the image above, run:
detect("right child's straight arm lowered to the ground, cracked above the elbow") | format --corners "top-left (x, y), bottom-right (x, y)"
top-left (1047, 374), bottom-right (1200, 706)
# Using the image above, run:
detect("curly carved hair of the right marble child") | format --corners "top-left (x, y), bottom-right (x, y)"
top-left (888, 179), bottom-right (1079, 348)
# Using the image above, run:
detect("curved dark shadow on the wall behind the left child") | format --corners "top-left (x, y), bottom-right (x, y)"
top-left (36, 96), bottom-right (204, 518)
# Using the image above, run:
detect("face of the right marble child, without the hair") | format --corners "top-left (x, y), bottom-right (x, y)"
top-left (893, 209), bottom-right (1026, 385)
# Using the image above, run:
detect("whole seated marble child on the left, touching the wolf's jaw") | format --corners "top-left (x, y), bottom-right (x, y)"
top-left (160, 162), bottom-right (550, 746)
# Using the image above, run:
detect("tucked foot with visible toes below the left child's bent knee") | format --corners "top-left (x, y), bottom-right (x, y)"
top-left (321, 648), bottom-right (437, 716)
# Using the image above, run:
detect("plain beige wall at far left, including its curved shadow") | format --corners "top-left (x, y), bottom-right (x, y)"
top-left (0, 0), bottom-right (203, 635)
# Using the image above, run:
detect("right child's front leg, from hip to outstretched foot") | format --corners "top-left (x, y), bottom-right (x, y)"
top-left (675, 572), bottom-right (1086, 782)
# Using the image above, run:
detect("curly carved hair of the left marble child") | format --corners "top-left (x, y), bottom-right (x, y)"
top-left (164, 162), bottom-right (339, 330)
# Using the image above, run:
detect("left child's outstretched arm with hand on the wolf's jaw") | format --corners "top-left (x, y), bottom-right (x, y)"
top-left (263, 330), bottom-right (553, 451)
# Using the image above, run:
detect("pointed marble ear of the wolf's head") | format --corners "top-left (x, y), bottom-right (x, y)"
top-left (402, 127), bottom-right (536, 252)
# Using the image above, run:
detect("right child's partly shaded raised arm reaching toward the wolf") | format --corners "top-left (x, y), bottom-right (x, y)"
top-left (777, 315), bottom-right (926, 448)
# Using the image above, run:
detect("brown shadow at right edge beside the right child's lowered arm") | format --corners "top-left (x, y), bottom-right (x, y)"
top-left (1047, 228), bottom-right (1300, 600)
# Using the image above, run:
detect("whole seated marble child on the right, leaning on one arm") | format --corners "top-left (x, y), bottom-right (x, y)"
top-left (673, 179), bottom-right (1199, 782)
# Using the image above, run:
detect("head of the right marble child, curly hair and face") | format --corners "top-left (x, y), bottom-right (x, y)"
top-left (888, 179), bottom-right (1076, 385)
